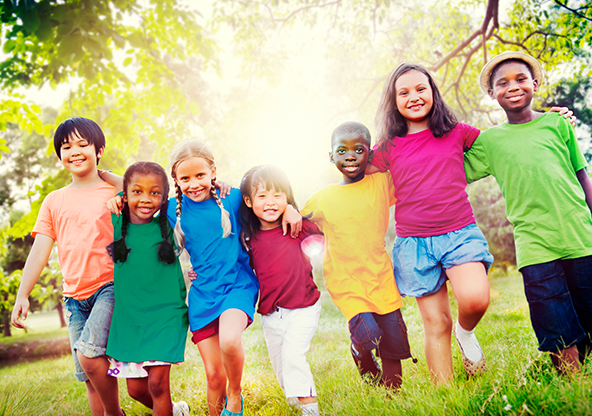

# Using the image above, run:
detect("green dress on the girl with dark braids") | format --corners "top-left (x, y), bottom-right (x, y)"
top-left (107, 215), bottom-right (189, 363)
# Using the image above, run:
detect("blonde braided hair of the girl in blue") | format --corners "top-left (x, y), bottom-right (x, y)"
top-left (169, 140), bottom-right (232, 249)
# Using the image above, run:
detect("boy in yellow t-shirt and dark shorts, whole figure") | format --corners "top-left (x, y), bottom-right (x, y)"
top-left (301, 122), bottom-right (411, 389)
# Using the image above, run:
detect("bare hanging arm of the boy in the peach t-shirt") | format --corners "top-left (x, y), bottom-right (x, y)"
top-left (11, 234), bottom-right (54, 329)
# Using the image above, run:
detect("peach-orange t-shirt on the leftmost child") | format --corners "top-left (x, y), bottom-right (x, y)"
top-left (31, 183), bottom-right (115, 300)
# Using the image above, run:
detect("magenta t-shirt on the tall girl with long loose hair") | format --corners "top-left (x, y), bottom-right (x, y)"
top-left (372, 123), bottom-right (480, 237)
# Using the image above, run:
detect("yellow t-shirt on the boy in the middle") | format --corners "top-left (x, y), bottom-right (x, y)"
top-left (301, 172), bottom-right (402, 321)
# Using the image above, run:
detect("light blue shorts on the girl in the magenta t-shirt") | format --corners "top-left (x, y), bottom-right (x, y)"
top-left (393, 224), bottom-right (493, 297)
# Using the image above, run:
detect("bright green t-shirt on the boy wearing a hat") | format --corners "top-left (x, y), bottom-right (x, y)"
top-left (465, 113), bottom-right (592, 268)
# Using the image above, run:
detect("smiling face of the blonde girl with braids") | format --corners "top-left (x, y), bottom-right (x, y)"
top-left (175, 157), bottom-right (216, 202)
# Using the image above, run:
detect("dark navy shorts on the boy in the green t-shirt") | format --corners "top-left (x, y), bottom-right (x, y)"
top-left (520, 256), bottom-right (592, 352)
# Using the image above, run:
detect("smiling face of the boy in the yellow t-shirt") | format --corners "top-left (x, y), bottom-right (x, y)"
top-left (329, 133), bottom-right (372, 183)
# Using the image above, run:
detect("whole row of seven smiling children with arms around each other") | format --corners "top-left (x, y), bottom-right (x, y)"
top-left (12, 52), bottom-right (592, 416)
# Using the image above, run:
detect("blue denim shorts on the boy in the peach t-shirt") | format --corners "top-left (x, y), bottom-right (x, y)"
top-left (64, 282), bottom-right (115, 381)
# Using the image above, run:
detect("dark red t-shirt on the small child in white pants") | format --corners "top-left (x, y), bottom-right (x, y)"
top-left (250, 220), bottom-right (321, 315)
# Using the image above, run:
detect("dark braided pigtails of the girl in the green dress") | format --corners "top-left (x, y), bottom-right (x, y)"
top-left (113, 162), bottom-right (176, 264)
